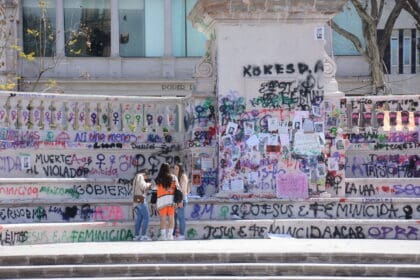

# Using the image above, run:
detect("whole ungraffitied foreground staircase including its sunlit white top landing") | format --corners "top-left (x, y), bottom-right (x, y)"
top-left (0, 238), bottom-right (420, 280)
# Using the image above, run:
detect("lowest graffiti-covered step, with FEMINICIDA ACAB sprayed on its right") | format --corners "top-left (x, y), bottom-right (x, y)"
top-left (0, 219), bottom-right (420, 245)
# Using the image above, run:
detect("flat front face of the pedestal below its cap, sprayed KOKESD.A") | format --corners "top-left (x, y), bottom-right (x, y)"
top-left (216, 22), bottom-right (332, 198)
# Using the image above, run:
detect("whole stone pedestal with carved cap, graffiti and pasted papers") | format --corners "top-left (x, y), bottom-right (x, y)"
top-left (190, 0), bottom-right (346, 198)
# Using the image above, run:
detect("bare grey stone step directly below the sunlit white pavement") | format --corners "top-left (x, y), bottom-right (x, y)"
top-left (0, 249), bottom-right (420, 267)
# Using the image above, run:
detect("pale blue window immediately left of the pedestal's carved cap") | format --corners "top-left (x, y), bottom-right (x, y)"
top-left (172, 0), bottom-right (206, 57)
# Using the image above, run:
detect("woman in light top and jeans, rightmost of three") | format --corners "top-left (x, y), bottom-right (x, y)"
top-left (174, 164), bottom-right (190, 240)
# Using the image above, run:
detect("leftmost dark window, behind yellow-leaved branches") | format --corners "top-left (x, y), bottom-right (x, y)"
top-left (22, 0), bottom-right (56, 56)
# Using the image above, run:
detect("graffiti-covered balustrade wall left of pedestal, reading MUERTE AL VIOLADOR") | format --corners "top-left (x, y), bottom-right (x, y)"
top-left (0, 93), bottom-right (183, 179)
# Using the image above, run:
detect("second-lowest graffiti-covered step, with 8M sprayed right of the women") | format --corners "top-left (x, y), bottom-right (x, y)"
top-left (0, 196), bottom-right (420, 224)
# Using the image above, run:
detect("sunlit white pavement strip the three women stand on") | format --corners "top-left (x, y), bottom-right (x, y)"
top-left (0, 237), bottom-right (420, 261)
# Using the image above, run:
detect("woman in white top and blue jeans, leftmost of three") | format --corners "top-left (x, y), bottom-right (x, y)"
top-left (133, 170), bottom-right (151, 241)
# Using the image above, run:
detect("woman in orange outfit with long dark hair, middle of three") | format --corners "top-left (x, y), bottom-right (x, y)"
top-left (155, 163), bottom-right (179, 240)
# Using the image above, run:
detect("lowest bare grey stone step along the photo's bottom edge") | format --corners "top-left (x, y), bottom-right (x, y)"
top-left (0, 262), bottom-right (420, 279)
